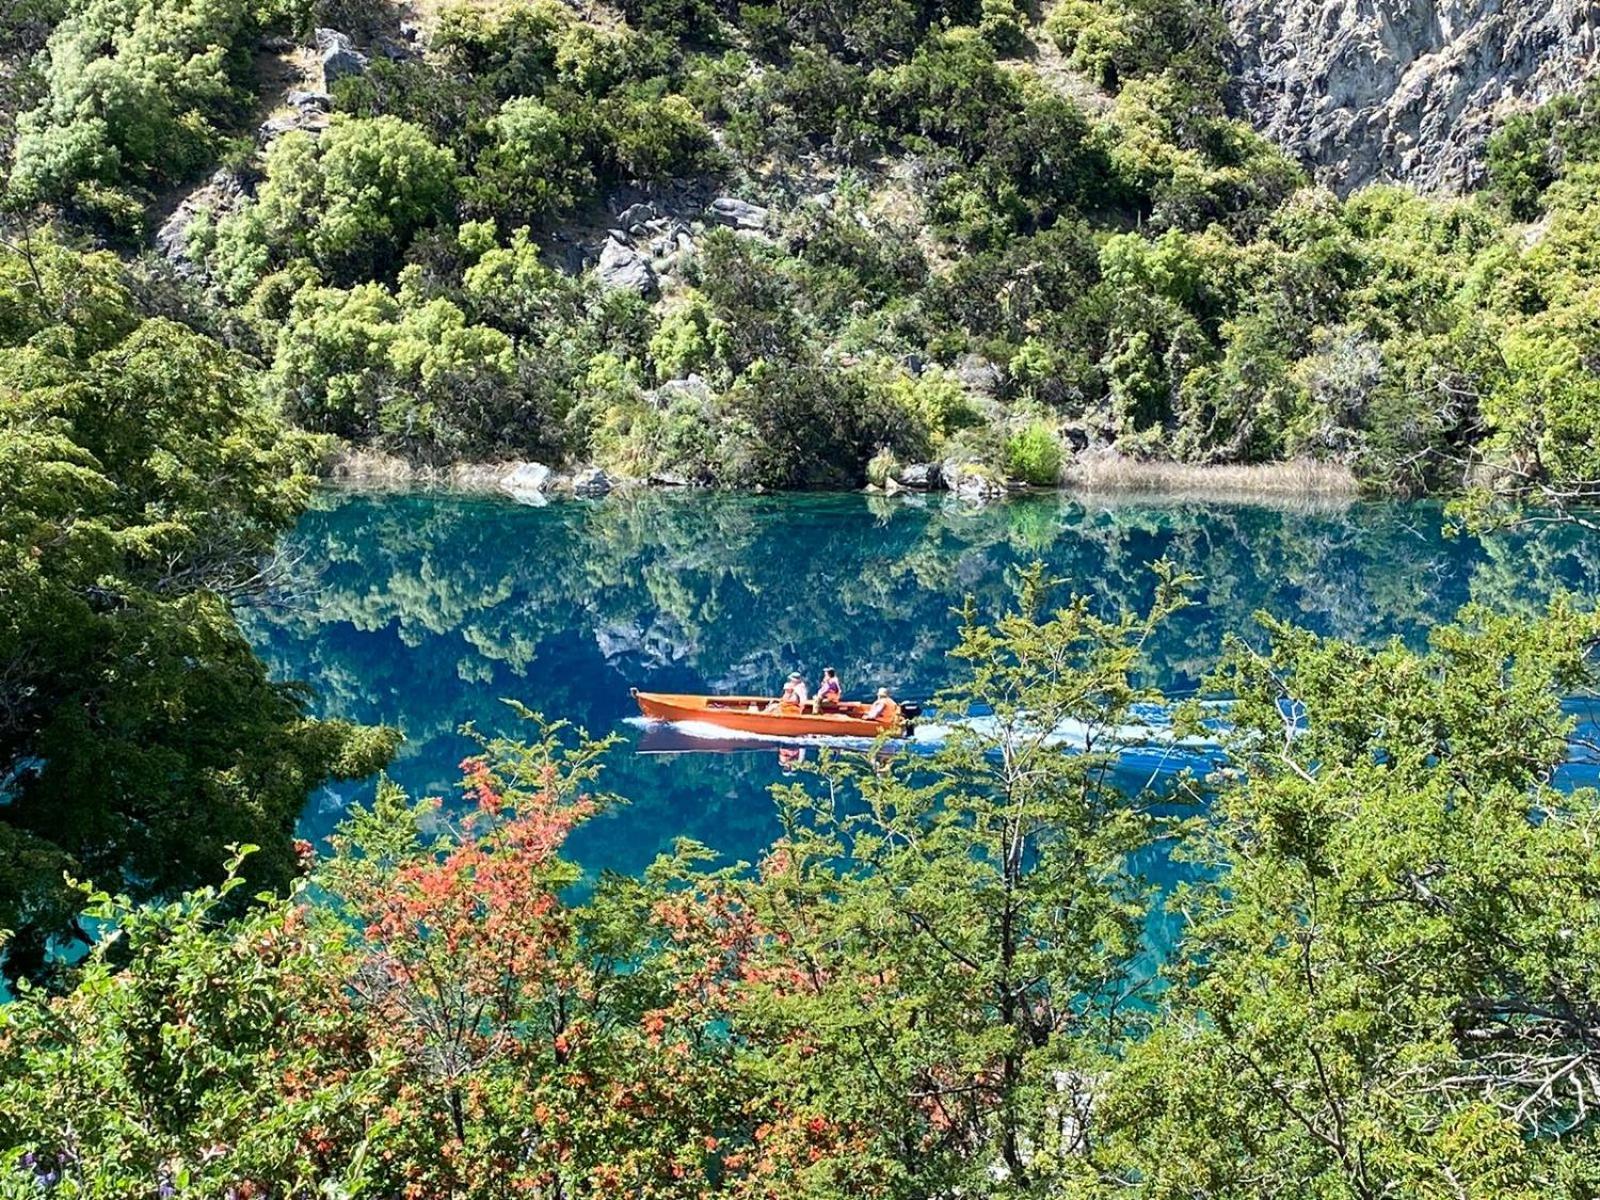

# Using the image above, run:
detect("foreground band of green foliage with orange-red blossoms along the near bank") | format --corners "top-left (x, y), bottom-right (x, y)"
top-left (9, 563), bottom-right (1600, 1200)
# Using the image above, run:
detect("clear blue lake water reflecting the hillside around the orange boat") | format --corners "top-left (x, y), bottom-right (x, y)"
top-left (243, 491), bottom-right (1600, 874)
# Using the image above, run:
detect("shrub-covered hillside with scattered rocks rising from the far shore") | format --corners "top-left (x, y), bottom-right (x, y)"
top-left (0, 0), bottom-right (1600, 496)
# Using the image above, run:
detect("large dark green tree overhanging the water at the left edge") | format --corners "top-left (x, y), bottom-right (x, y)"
top-left (0, 242), bottom-right (392, 974)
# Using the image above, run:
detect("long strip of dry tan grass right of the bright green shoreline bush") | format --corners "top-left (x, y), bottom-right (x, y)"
top-left (1067, 454), bottom-right (1358, 504)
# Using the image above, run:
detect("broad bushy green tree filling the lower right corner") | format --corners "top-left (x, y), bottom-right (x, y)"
top-left (1099, 603), bottom-right (1600, 1200)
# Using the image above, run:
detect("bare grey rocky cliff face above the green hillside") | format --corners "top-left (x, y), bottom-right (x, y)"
top-left (1222, 0), bottom-right (1600, 192)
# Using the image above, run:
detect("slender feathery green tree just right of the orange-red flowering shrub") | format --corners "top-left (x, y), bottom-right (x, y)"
top-left (656, 565), bottom-right (1187, 1197)
